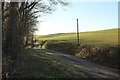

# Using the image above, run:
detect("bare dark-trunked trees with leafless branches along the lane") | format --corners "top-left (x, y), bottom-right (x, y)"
top-left (2, 0), bottom-right (67, 59)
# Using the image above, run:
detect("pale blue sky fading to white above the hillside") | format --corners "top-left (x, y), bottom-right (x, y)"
top-left (36, 2), bottom-right (118, 35)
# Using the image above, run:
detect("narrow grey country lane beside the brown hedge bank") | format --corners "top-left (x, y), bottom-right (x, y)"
top-left (42, 50), bottom-right (119, 78)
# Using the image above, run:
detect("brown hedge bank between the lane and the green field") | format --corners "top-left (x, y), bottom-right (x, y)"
top-left (46, 43), bottom-right (120, 68)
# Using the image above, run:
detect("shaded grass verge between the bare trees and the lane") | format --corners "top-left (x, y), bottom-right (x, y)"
top-left (14, 49), bottom-right (88, 78)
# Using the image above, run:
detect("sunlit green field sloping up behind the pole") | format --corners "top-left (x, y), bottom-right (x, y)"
top-left (37, 28), bottom-right (120, 46)
